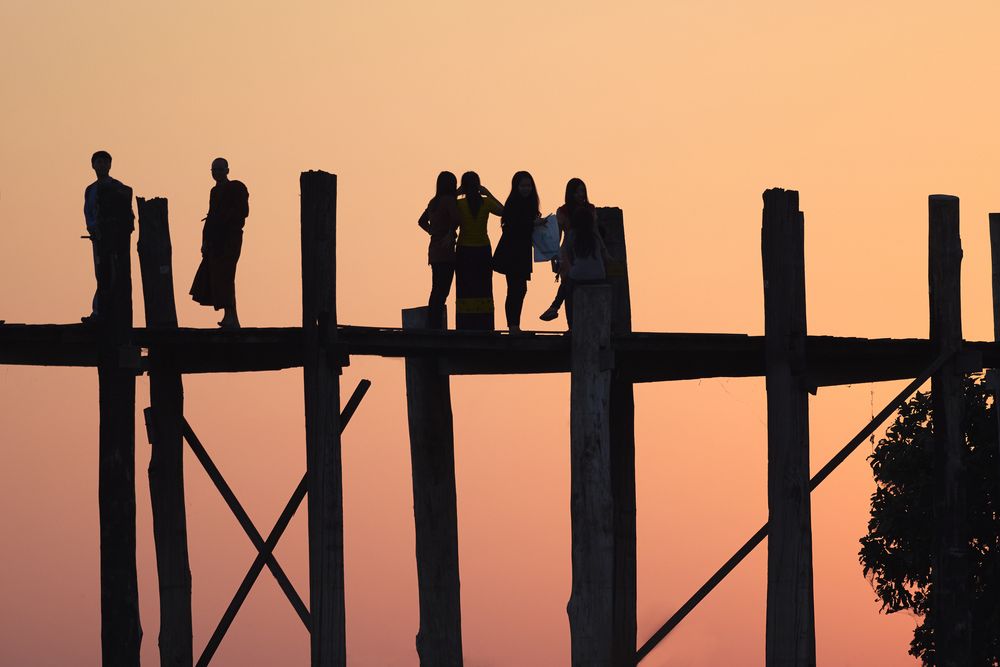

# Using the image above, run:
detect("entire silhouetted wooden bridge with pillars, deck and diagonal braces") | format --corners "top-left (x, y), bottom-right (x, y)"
top-left (0, 172), bottom-right (988, 666)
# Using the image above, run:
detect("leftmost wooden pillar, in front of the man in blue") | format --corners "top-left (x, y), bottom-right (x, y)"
top-left (97, 191), bottom-right (142, 665)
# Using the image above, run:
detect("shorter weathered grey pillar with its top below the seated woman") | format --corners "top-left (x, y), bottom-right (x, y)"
top-left (566, 285), bottom-right (615, 667)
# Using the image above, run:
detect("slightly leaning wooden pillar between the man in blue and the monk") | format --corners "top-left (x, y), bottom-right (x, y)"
top-left (136, 197), bottom-right (193, 666)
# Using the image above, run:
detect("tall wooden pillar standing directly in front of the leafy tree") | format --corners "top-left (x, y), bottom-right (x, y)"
top-left (928, 195), bottom-right (972, 667)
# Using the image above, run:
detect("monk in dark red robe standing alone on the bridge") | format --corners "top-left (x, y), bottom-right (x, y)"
top-left (191, 157), bottom-right (250, 329)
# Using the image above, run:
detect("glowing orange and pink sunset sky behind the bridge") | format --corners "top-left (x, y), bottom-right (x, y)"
top-left (0, 0), bottom-right (1000, 667)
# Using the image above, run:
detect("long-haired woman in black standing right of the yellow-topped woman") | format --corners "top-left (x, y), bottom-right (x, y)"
top-left (493, 171), bottom-right (542, 333)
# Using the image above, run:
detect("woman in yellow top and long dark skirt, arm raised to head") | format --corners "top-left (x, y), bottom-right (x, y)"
top-left (455, 171), bottom-right (503, 331)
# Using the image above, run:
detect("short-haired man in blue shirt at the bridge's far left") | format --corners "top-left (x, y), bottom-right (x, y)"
top-left (81, 151), bottom-right (135, 323)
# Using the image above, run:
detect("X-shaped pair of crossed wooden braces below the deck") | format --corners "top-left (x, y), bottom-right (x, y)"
top-left (184, 380), bottom-right (372, 667)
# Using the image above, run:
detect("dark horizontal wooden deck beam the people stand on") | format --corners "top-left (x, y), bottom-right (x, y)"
top-left (0, 324), bottom-right (1000, 388)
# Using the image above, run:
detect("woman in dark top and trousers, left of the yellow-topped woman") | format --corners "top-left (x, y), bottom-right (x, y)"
top-left (417, 171), bottom-right (459, 329)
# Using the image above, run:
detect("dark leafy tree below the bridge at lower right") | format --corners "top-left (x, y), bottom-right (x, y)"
top-left (859, 376), bottom-right (1000, 665)
